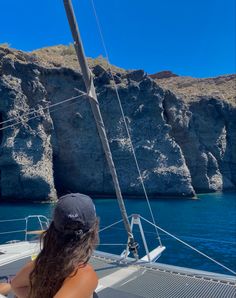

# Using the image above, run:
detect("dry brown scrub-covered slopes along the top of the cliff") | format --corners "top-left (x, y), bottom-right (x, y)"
top-left (0, 44), bottom-right (236, 106)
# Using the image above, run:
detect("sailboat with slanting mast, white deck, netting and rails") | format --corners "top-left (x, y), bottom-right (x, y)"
top-left (0, 0), bottom-right (236, 298)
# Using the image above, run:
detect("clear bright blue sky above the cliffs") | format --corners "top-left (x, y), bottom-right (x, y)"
top-left (0, 0), bottom-right (236, 77)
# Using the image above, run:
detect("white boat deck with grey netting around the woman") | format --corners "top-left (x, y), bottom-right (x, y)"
top-left (0, 242), bottom-right (236, 298)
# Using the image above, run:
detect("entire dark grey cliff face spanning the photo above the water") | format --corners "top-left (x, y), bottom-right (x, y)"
top-left (0, 48), bottom-right (236, 201)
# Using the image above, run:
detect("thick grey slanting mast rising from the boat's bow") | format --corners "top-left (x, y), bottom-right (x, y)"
top-left (63, 0), bottom-right (138, 259)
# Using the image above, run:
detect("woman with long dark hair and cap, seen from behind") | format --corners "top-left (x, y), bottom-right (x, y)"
top-left (11, 193), bottom-right (98, 298)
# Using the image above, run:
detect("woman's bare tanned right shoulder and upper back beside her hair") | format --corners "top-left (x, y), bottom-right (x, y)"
top-left (54, 264), bottom-right (98, 298)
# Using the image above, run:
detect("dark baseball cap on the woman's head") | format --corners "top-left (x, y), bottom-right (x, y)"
top-left (53, 193), bottom-right (97, 233)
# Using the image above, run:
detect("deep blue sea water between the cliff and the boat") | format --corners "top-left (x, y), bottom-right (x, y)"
top-left (0, 192), bottom-right (236, 274)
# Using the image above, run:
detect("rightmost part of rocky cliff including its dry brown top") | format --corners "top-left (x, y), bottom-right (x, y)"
top-left (154, 75), bottom-right (236, 192)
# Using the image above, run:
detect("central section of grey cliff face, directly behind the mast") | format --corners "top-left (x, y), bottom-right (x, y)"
top-left (41, 67), bottom-right (194, 196)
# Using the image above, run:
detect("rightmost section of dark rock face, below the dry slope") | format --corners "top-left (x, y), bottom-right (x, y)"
top-left (163, 92), bottom-right (236, 192)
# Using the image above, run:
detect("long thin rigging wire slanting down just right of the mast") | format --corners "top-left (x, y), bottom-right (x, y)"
top-left (90, 0), bottom-right (162, 246)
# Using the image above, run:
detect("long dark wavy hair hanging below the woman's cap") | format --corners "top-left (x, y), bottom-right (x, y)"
top-left (28, 219), bottom-right (99, 298)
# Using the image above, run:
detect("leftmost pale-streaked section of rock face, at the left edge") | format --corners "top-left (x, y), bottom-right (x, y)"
top-left (0, 49), bottom-right (56, 201)
